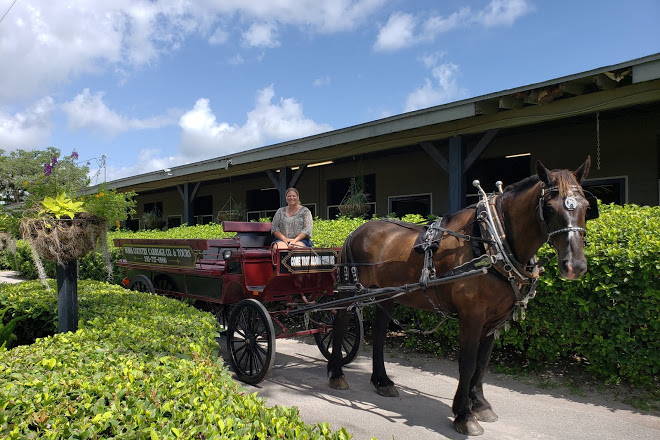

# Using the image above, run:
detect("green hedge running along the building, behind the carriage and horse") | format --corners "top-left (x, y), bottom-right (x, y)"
top-left (5, 205), bottom-right (660, 385)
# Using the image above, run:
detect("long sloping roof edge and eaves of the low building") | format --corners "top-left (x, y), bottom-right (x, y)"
top-left (95, 53), bottom-right (660, 191)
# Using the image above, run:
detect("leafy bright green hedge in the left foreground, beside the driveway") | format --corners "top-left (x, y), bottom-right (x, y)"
top-left (0, 280), bottom-right (351, 439)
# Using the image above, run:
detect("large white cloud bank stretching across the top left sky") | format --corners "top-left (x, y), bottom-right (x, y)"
top-left (0, 0), bottom-right (386, 101)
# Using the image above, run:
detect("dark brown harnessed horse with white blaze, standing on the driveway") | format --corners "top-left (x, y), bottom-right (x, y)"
top-left (328, 158), bottom-right (597, 435)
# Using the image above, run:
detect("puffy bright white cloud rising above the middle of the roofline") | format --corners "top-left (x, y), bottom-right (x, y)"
top-left (179, 86), bottom-right (332, 160)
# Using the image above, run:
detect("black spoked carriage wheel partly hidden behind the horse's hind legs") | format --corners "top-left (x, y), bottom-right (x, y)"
top-left (312, 297), bottom-right (364, 365)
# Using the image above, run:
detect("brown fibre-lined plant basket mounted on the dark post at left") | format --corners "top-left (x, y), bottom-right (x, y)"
top-left (20, 213), bottom-right (107, 266)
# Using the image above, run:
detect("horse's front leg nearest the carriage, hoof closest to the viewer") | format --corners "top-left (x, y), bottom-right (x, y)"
top-left (452, 315), bottom-right (484, 435)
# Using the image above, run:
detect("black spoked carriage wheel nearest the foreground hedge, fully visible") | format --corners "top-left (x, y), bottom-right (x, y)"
top-left (227, 299), bottom-right (275, 385)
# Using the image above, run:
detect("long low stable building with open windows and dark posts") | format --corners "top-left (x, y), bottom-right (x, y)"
top-left (102, 54), bottom-right (660, 228)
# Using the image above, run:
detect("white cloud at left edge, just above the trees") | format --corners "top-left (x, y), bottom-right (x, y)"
top-left (0, 96), bottom-right (55, 151)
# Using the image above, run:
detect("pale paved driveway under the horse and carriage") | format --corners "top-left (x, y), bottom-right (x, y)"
top-left (221, 337), bottom-right (660, 440)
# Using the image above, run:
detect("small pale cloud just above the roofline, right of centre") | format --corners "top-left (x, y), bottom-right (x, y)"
top-left (405, 63), bottom-right (467, 112)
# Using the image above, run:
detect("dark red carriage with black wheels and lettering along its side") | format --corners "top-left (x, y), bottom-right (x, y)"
top-left (114, 221), bottom-right (364, 384)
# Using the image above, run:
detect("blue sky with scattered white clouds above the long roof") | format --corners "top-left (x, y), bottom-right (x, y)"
top-left (0, 0), bottom-right (660, 183)
